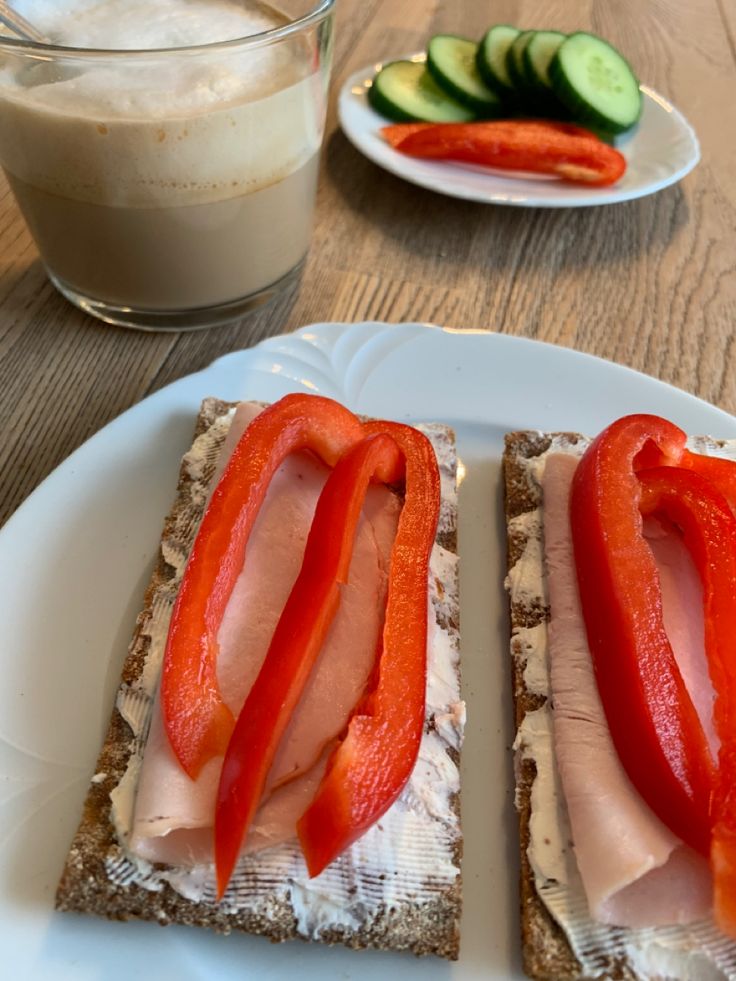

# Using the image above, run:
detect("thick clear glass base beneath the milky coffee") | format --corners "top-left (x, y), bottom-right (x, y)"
top-left (46, 260), bottom-right (304, 332)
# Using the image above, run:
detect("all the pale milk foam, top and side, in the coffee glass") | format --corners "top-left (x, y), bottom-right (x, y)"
top-left (0, 0), bottom-right (324, 207)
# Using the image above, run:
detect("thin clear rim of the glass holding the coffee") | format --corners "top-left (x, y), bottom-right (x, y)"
top-left (0, 0), bottom-right (335, 60)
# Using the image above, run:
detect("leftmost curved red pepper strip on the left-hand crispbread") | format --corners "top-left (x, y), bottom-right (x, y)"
top-left (161, 394), bottom-right (363, 779)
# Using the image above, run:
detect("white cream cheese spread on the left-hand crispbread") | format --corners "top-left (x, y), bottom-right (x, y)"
top-left (106, 413), bottom-right (465, 939)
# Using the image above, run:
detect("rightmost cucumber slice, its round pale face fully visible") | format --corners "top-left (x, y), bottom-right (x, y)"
top-left (549, 31), bottom-right (642, 133)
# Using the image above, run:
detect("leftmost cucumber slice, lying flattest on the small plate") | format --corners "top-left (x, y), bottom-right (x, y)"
top-left (368, 61), bottom-right (475, 123)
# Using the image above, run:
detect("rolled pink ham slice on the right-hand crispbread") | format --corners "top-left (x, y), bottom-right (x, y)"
top-left (543, 454), bottom-right (712, 927)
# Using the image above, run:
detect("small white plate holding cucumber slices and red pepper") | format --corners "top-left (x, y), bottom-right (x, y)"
top-left (338, 54), bottom-right (700, 208)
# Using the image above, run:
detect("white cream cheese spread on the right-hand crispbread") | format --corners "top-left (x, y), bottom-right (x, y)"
top-left (506, 437), bottom-right (736, 981)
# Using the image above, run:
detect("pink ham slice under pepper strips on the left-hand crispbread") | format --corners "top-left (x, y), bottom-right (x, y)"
top-left (130, 404), bottom-right (400, 865)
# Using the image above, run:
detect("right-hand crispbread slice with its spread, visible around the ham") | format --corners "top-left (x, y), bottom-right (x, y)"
top-left (504, 431), bottom-right (736, 981)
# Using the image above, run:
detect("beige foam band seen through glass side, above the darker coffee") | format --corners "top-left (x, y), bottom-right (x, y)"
top-left (0, 78), bottom-right (321, 208)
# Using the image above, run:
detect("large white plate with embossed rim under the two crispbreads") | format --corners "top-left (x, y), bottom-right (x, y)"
top-left (0, 323), bottom-right (736, 981)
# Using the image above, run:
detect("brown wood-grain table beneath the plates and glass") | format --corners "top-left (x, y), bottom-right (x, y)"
top-left (0, 0), bottom-right (736, 523)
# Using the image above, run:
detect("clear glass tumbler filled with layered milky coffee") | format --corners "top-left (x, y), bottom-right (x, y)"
top-left (0, 0), bottom-right (334, 330)
